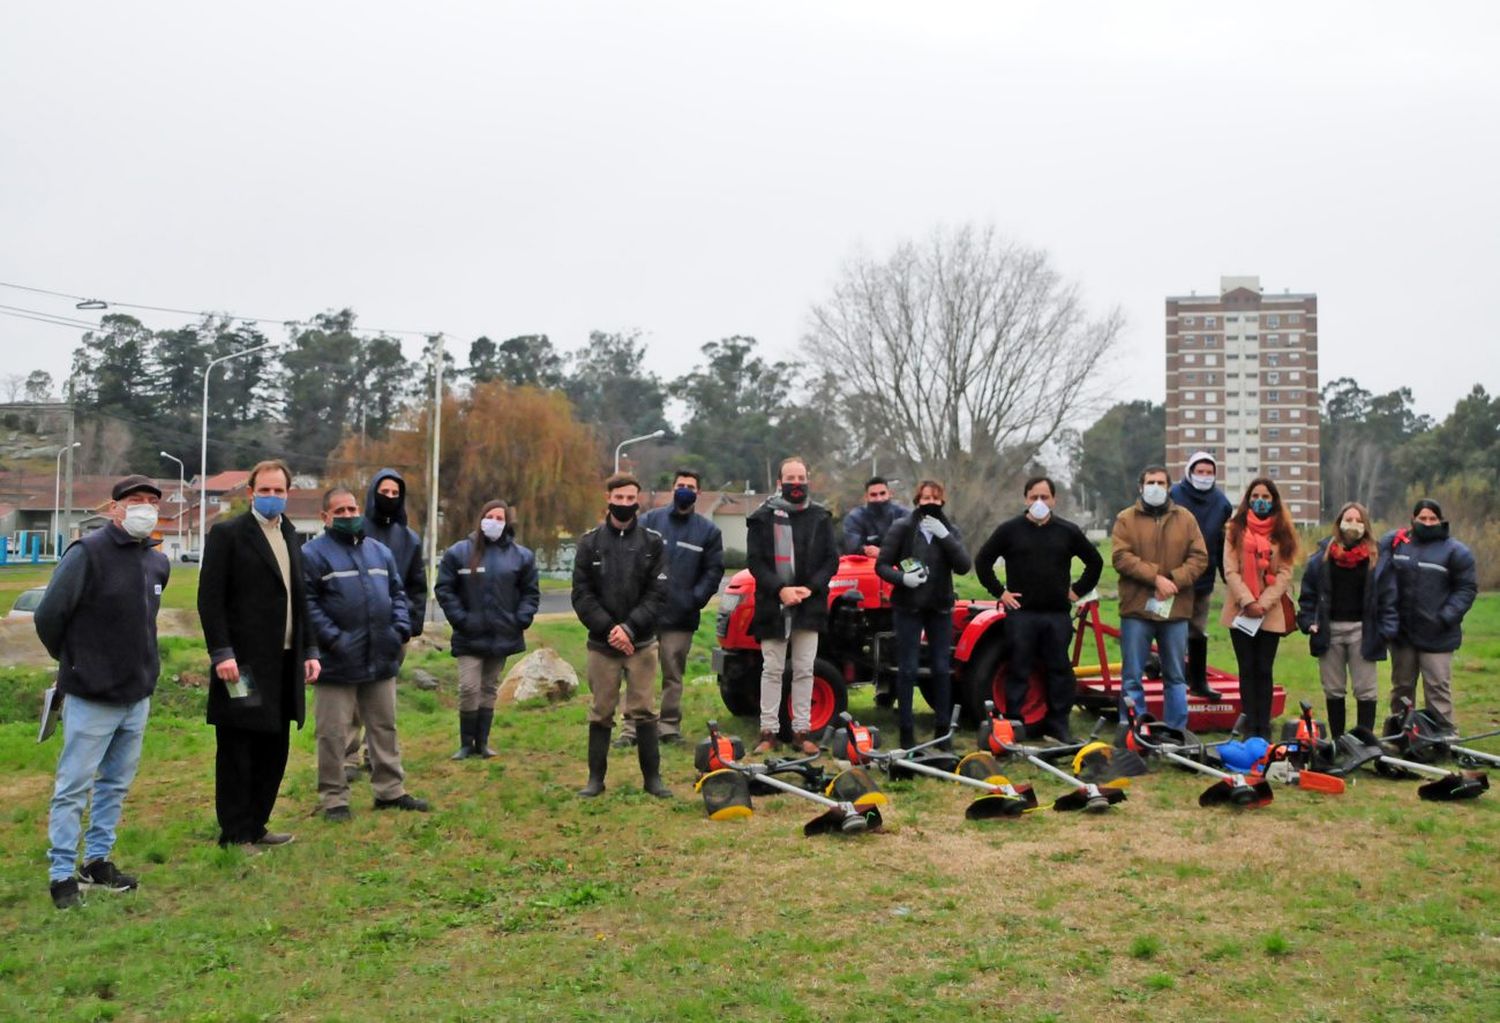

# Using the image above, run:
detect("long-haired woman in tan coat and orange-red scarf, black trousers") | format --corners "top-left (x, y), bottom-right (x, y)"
top-left (1221, 477), bottom-right (1298, 740)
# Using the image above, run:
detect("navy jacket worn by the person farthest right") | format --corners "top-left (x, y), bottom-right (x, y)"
top-left (1380, 522), bottom-right (1479, 654)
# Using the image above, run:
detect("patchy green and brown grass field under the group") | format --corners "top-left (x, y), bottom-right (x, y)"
top-left (0, 561), bottom-right (1500, 1023)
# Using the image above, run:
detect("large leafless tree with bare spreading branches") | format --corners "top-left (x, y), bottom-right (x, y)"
top-left (807, 225), bottom-right (1124, 531)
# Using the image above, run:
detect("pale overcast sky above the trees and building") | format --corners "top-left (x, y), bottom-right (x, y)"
top-left (0, 0), bottom-right (1500, 417)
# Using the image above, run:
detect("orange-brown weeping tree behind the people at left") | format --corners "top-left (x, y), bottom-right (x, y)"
top-left (329, 380), bottom-right (606, 552)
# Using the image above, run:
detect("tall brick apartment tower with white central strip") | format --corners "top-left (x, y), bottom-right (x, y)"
top-left (1167, 278), bottom-right (1323, 524)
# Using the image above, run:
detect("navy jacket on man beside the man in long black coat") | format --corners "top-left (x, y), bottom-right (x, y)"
top-left (302, 533), bottom-right (411, 684)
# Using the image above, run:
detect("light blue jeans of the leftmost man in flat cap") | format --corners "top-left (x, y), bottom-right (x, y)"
top-left (47, 696), bottom-right (152, 881)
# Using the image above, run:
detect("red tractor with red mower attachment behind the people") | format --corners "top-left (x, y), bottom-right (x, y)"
top-left (714, 555), bottom-right (1286, 735)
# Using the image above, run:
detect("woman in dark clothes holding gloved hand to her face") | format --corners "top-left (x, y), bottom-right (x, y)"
top-left (875, 480), bottom-right (974, 749)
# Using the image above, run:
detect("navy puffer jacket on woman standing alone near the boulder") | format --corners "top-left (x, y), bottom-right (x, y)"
top-left (434, 525), bottom-right (542, 657)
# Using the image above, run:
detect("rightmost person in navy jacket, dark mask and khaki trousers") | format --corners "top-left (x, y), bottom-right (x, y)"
top-left (1380, 498), bottom-right (1479, 735)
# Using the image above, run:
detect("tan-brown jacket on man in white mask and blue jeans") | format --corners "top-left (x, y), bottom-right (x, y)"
top-left (1110, 501), bottom-right (1209, 621)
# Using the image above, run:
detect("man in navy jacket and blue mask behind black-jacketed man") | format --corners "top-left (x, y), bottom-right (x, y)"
top-left (614, 470), bottom-right (725, 749)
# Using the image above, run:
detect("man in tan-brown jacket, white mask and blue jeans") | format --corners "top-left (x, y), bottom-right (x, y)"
top-left (1110, 465), bottom-right (1209, 729)
